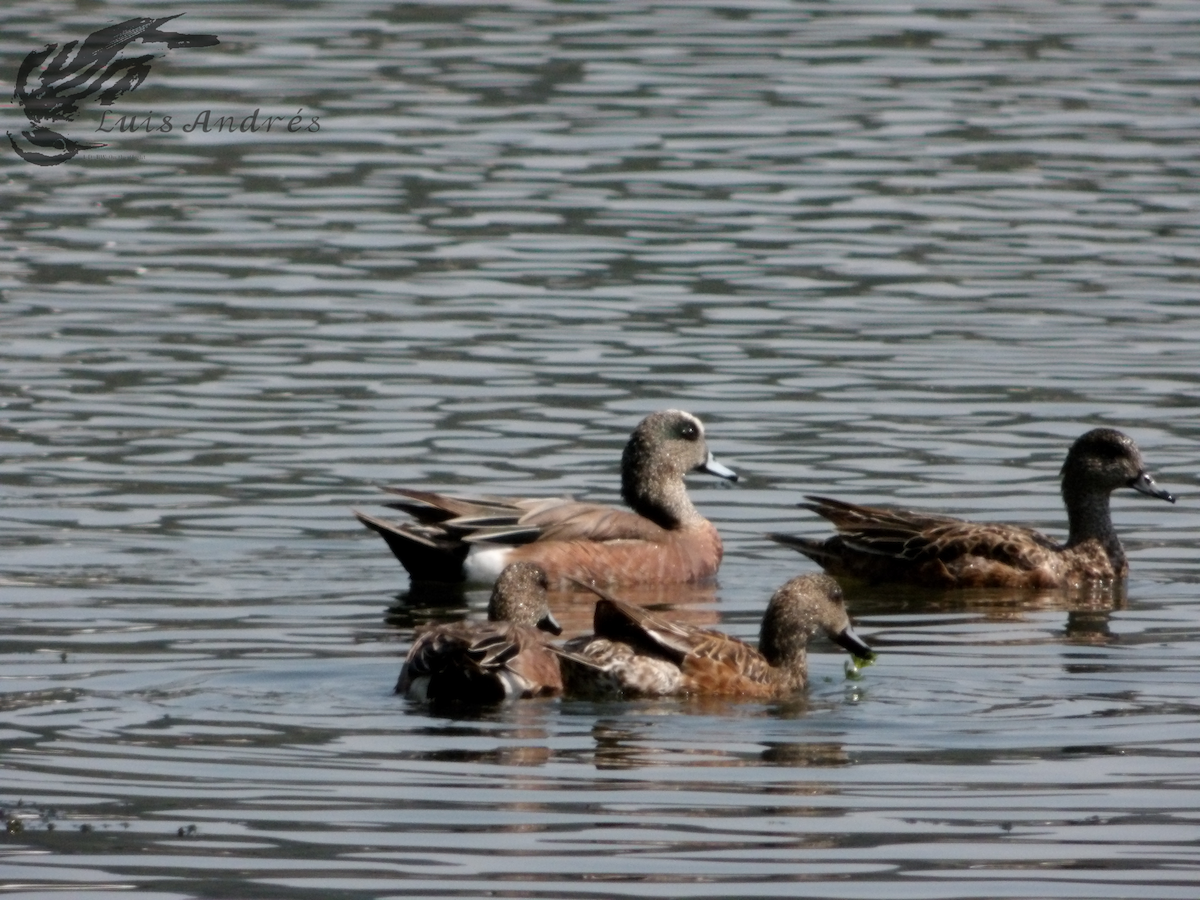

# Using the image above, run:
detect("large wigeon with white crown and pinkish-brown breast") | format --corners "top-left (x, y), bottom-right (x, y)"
top-left (354, 409), bottom-right (738, 584)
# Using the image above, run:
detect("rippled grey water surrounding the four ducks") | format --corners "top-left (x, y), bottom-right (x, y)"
top-left (0, 0), bottom-right (1200, 900)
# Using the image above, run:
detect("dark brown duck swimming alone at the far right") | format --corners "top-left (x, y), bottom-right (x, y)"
top-left (767, 428), bottom-right (1175, 588)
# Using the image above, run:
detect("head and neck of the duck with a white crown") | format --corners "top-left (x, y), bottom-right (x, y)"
top-left (620, 409), bottom-right (738, 528)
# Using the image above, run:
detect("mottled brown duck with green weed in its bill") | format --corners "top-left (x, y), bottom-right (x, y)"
top-left (556, 574), bottom-right (874, 697)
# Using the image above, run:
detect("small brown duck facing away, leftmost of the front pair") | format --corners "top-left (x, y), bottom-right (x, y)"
top-left (396, 563), bottom-right (563, 703)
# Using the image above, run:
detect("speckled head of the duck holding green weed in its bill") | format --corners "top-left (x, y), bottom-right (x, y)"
top-left (758, 574), bottom-right (875, 668)
